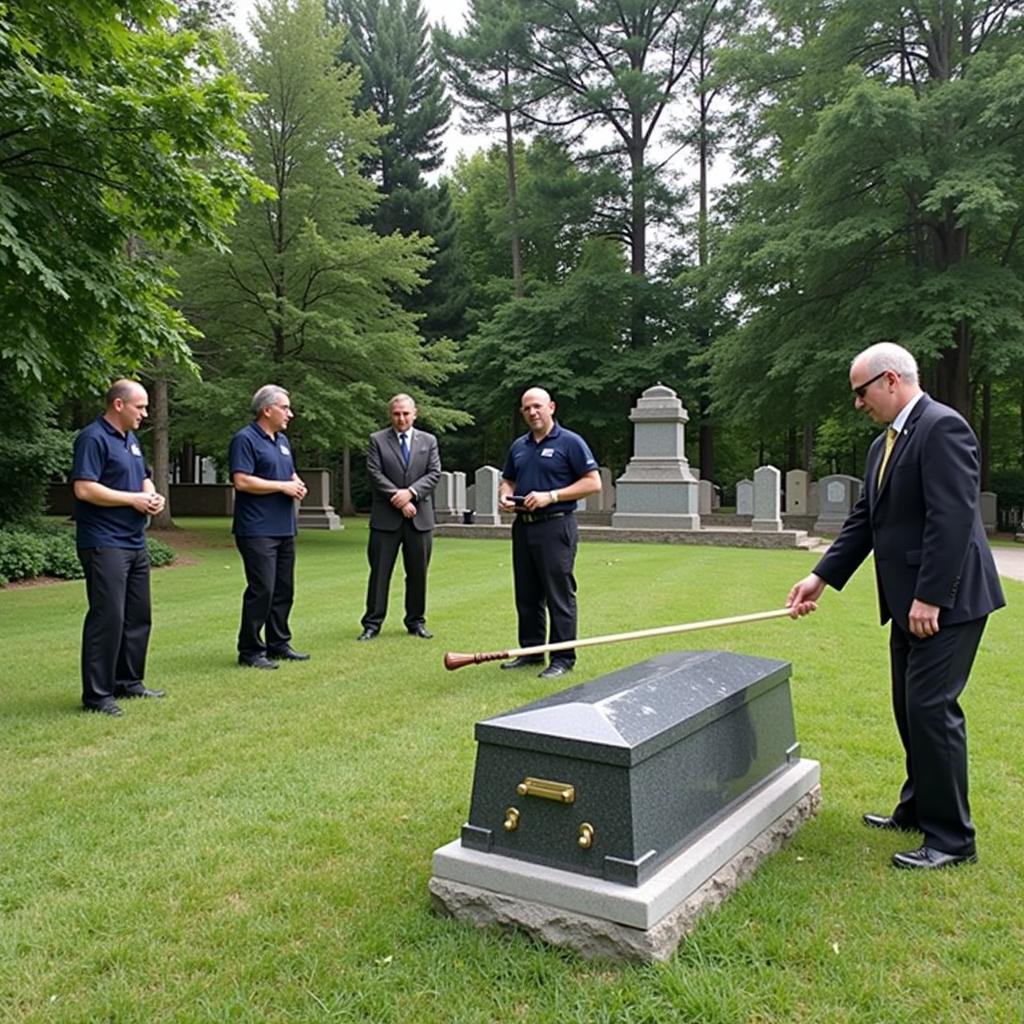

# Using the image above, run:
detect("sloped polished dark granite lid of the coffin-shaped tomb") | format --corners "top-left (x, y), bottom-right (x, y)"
top-left (475, 650), bottom-right (791, 766)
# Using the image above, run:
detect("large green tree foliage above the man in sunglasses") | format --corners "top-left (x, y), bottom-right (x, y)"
top-left (715, 0), bottom-right (1024, 421)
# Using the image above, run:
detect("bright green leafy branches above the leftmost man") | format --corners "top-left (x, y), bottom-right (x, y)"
top-left (0, 0), bottom-right (268, 395)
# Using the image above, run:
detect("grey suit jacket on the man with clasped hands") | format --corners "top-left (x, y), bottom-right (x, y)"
top-left (367, 427), bottom-right (441, 530)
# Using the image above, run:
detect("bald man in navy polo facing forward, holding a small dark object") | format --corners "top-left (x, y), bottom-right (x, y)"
top-left (498, 387), bottom-right (601, 679)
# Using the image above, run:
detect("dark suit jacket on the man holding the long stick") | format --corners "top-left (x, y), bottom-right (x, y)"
top-left (814, 394), bottom-right (1006, 630)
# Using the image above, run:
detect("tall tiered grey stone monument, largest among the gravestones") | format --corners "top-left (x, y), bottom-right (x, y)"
top-left (611, 384), bottom-right (700, 530)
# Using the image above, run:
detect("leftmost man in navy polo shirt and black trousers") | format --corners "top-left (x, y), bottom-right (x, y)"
top-left (71, 380), bottom-right (165, 717)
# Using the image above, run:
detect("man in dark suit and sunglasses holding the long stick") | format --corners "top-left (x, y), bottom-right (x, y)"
top-left (786, 342), bottom-right (1006, 868)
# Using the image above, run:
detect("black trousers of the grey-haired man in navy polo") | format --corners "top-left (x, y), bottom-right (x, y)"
top-left (234, 536), bottom-right (295, 657)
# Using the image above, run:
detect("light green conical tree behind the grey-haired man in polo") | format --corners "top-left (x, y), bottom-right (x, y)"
top-left (175, 0), bottom-right (467, 454)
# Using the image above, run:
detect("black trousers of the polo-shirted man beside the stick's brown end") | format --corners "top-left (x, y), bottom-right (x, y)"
top-left (512, 515), bottom-right (579, 666)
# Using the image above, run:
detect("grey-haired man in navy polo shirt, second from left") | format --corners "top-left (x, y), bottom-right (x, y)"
top-left (227, 384), bottom-right (309, 669)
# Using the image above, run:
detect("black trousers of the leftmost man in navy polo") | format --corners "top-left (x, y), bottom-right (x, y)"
top-left (78, 548), bottom-right (153, 708)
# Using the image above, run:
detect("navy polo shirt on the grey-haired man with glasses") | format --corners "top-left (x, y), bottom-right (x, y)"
top-left (227, 421), bottom-right (295, 537)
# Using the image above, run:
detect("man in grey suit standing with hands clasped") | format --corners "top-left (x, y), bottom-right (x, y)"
top-left (358, 394), bottom-right (441, 640)
